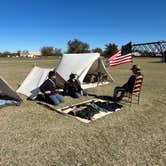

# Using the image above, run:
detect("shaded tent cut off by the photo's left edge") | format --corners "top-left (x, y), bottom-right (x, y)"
top-left (0, 76), bottom-right (21, 101)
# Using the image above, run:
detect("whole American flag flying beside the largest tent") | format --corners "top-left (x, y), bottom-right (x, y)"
top-left (108, 42), bottom-right (133, 67)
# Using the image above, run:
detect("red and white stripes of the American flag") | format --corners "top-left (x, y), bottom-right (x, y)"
top-left (108, 50), bottom-right (133, 67)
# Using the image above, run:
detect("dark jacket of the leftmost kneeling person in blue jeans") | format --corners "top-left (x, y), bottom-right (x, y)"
top-left (39, 79), bottom-right (56, 96)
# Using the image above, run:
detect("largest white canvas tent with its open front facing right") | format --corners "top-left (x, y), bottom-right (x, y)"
top-left (56, 53), bottom-right (113, 87)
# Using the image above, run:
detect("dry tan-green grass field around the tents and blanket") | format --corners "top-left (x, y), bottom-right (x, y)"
top-left (0, 58), bottom-right (166, 166)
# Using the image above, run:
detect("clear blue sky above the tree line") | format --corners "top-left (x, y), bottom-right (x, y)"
top-left (0, 0), bottom-right (166, 52)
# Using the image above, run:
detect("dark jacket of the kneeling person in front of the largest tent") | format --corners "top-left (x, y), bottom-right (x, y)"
top-left (64, 79), bottom-right (82, 95)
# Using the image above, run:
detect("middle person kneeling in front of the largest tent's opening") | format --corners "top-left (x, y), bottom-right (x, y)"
top-left (64, 73), bottom-right (87, 98)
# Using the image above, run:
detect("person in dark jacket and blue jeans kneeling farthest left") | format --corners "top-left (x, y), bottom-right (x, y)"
top-left (39, 71), bottom-right (64, 105)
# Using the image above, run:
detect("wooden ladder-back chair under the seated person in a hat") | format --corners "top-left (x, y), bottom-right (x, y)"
top-left (128, 75), bottom-right (144, 106)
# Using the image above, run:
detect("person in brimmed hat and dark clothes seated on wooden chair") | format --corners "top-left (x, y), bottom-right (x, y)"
top-left (113, 65), bottom-right (141, 100)
